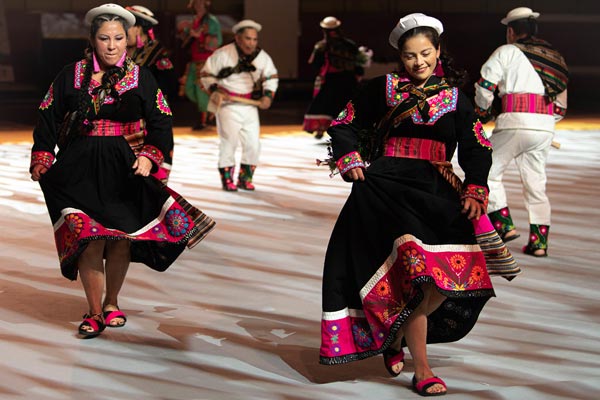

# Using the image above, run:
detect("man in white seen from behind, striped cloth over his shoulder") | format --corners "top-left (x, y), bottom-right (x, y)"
top-left (475, 7), bottom-right (568, 257)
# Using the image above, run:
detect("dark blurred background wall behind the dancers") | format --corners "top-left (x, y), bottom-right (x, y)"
top-left (0, 0), bottom-right (600, 123)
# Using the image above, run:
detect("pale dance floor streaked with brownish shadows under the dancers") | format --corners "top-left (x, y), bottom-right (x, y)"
top-left (0, 127), bottom-right (600, 400)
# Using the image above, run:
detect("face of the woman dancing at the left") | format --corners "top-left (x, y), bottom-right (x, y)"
top-left (92, 21), bottom-right (127, 69)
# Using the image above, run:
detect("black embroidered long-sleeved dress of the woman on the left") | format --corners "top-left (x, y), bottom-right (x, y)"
top-left (31, 59), bottom-right (215, 280)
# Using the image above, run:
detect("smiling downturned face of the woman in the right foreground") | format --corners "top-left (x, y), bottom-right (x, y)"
top-left (400, 33), bottom-right (440, 86)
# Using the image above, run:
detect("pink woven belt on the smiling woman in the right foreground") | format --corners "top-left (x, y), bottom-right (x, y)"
top-left (383, 137), bottom-right (446, 161)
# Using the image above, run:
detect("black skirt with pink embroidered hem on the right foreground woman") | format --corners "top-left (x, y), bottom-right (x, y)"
top-left (320, 157), bottom-right (494, 364)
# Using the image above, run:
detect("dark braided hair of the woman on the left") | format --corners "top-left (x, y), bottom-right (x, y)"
top-left (73, 14), bottom-right (129, 134)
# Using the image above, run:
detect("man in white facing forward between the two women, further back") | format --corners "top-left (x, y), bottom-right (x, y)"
top-left (201, 19), bottom-right (279, 191)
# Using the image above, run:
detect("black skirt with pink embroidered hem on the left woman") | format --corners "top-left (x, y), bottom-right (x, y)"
top-left (40, 136), bottom-right (215, 280)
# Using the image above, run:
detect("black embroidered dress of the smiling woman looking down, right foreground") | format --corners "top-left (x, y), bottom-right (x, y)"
top-left (320, 74), bottom-right (494, 364)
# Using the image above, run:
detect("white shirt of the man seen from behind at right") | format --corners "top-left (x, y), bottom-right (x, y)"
top-left (475, 44), bottom-right (567, 132)
